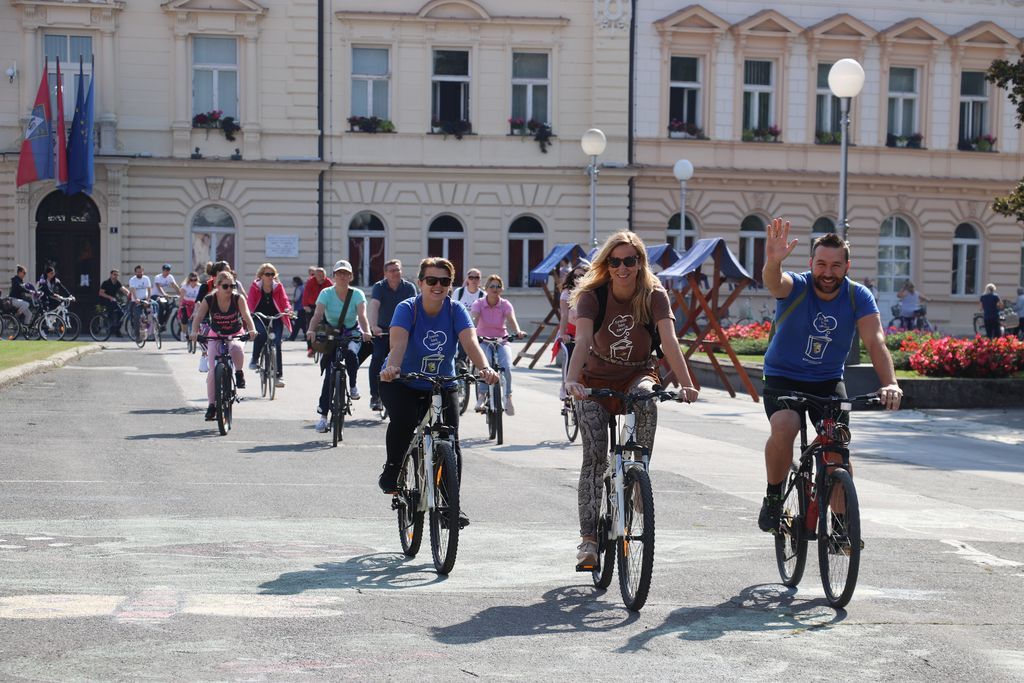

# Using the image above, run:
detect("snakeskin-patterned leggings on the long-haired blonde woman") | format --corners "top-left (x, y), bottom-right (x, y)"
top-left (577, 376), bottom-right (657, 537)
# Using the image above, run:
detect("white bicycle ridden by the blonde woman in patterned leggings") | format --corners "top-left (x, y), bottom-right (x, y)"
top-left (577, 386), bottom-right (677, 611)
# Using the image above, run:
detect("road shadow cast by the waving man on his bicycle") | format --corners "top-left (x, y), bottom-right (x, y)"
top-left (617, 584), bottom-right (846, 652)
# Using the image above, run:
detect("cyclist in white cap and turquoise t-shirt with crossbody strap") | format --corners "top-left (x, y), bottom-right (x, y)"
top-left (306, 259), bottom-right (371, 434)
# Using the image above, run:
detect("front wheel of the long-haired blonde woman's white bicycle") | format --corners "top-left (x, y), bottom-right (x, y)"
top-left (616, 467), bottom-right (654, 611)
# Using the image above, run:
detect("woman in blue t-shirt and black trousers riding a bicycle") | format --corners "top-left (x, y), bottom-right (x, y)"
top-left (378, 257), bottom-right (498, 494)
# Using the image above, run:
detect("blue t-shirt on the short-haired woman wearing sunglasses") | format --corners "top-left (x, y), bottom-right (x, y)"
top-left (384, 296), bottom-right (473, 390)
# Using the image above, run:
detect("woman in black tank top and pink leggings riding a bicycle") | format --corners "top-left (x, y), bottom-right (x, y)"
top-left (190, 270), bottom-right (256, 422)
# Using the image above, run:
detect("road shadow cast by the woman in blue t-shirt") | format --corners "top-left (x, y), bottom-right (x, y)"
top-left (259, 553), bottom-right (447, 595)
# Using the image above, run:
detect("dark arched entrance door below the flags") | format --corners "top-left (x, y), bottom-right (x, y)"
top-left (35, 190), bottom-right (102, 325)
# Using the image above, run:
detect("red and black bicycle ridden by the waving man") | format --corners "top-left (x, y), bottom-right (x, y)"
top-left (766, 390), bottom-right (884, 609)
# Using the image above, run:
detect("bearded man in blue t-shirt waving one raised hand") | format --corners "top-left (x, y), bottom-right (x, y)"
top-left (758, 218), bottom-right (901, 531)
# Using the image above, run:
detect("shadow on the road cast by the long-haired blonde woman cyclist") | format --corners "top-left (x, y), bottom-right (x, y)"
top-left (430, 586), bottom-right (640, 644)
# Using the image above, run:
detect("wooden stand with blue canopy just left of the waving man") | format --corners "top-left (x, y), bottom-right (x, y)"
top-left (657, 238), bottom-right (760, 401)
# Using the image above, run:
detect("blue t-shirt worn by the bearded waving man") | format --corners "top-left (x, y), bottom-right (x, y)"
top-left (764, 271), bottom-right (879, 382)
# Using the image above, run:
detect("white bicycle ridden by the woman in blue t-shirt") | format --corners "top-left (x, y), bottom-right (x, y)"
top-left (391, 373), bottom-right (476, 574)
